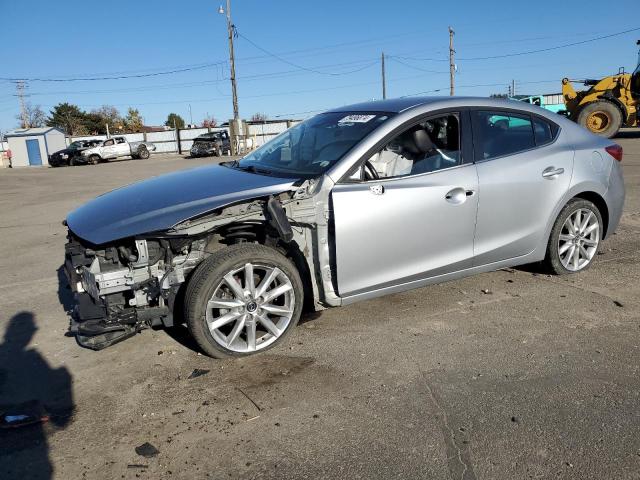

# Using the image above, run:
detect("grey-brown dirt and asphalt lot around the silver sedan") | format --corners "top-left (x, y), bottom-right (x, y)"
top-left (0, 137), bottom-right (640, 480)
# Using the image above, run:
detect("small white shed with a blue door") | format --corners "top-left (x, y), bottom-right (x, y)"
top-left (5, 127), bottom-right (67, 167)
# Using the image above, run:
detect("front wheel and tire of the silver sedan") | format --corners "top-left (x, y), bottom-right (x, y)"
top-left (184, 243), bottom-right (304, 358)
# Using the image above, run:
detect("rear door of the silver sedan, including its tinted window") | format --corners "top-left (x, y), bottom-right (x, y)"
top-left (472, 109), bottom-right (574, 266)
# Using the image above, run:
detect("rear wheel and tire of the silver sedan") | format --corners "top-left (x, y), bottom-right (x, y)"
top-left (544, 198), bottom-right (604, 275)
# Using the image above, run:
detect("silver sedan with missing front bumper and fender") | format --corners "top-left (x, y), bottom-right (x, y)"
top-left (65, 97), bottom-right (624, 357)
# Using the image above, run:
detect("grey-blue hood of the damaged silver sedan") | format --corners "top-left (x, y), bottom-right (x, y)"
top-left (67, 165), bottom-right (295, 245)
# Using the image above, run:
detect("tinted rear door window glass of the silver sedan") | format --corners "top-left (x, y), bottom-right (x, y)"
top-left (472, 111), bottom-right (536, 160)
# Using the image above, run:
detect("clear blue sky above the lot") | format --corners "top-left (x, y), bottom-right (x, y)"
top-left (0, 0), bottom-right (640, 131)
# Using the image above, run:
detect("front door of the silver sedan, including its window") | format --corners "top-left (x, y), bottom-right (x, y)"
top-left (332, 113), bottom-right (478, 297)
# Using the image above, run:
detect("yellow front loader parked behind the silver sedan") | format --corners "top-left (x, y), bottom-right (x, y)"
top-left (562, 40), bottom-right (640, 138)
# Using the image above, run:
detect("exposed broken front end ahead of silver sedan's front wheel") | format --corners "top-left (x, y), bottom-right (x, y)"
top-left (65, 231), bottom-right (206, 350)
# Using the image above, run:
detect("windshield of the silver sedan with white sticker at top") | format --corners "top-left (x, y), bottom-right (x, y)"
top-left (233, 112), bottom-right (393, 178)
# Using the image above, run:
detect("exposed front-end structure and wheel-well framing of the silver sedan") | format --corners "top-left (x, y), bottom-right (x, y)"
top-left (65, 181), bottom-right (338, 350)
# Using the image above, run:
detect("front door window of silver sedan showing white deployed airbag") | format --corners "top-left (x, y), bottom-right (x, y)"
top-left (361, 113), bottom-right (462, 181)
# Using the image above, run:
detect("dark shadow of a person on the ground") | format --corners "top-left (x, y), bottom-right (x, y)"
top-left (0, 312), bottom-right (74, 480)
